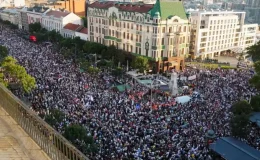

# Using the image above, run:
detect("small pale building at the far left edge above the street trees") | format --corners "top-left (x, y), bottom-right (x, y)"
top-left (0, 9), bottom-right (19, 25)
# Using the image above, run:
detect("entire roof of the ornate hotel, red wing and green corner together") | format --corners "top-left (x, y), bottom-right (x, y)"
top-left (89, 0), bottom-right (187, 19)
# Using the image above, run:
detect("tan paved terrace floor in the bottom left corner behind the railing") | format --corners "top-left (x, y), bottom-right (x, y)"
top-left (0, 107), bottom-right (50, 160)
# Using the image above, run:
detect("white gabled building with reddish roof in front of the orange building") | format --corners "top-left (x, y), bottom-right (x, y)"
top-left (41, 10), bottom-right (83, 32)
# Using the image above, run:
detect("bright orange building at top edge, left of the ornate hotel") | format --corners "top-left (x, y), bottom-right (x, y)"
top-left (49, 0), bottom-right (86, 17)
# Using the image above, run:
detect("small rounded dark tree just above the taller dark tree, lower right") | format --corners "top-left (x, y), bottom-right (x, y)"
top-left (231, 101), bottom-right (252, 115)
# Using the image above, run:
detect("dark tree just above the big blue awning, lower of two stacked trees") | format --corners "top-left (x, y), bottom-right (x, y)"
top-left (230, 114), bottom-right (250, 138)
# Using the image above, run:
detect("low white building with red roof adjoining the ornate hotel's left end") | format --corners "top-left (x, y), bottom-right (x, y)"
top-left (61, 23), bottom-right (88, 41)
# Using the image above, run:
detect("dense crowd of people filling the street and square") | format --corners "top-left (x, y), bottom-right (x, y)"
top-left (0, 26), bottom-right (260, 160)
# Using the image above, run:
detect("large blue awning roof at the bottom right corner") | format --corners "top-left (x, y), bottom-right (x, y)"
top-left (209, 137), bottom-right (260, 160)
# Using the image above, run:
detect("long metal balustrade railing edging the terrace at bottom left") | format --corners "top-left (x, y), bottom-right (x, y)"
top-left (0, 84), bottom-right (89, 160)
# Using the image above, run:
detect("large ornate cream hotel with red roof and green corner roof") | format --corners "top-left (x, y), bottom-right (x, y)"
top-left (87, 0), bottom-right (190, 70)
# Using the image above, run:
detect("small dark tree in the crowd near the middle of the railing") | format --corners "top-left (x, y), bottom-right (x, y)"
top-left (44, 109), bottom-right (65, 128)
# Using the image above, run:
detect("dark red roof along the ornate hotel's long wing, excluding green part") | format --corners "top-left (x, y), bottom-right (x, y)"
top-left (89, 1), bottom-right (154, 13)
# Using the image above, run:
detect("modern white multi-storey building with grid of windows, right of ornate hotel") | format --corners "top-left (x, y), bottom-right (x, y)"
top-left (189, 11), bottom-right (258, 58)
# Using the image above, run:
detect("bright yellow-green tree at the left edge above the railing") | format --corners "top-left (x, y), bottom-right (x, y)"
top-left (1, 56), bottom-right (36, 93)
